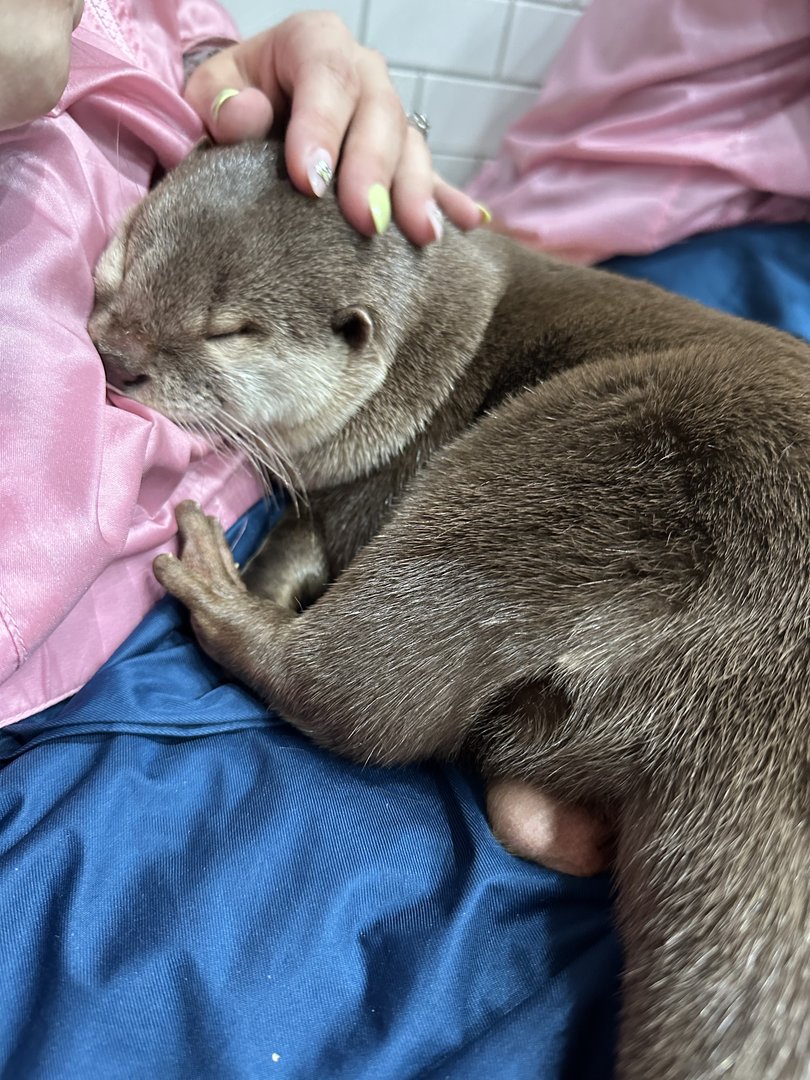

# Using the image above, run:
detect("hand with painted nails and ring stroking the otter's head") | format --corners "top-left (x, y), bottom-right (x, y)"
top-left (186, 12), bottom-right (487, 245)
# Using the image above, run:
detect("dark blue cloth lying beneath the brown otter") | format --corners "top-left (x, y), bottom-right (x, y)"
top-left (0, 226), bottom-right (810, 1080)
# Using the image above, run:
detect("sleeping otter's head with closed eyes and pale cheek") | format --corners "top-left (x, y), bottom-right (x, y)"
top-left (89, 143), bottom-right (412, 473)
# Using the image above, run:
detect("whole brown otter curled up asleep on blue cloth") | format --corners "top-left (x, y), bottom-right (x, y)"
top-left (91, 143), bottom-right (810, 1080)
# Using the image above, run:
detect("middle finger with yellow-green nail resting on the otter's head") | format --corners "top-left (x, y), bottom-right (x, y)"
top-left (330, 51), bottom-right (408, 237)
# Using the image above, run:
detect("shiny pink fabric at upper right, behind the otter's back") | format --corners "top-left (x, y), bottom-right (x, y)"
top-left (470, 0), bottom-right (810, 261)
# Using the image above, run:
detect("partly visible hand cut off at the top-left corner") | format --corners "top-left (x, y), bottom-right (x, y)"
top-left (0, 0), bottom-right (84, 131)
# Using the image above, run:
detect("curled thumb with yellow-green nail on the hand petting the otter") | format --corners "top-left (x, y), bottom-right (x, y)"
top-left (185, 35), bottom-right (284, 143)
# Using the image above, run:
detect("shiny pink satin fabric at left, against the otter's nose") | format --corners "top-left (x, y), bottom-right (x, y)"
top-left (0, 0), bottom-right (260, 724)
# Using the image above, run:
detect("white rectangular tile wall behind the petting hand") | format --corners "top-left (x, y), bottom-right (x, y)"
top-left (225, 0), bottom-right (589, 185)
